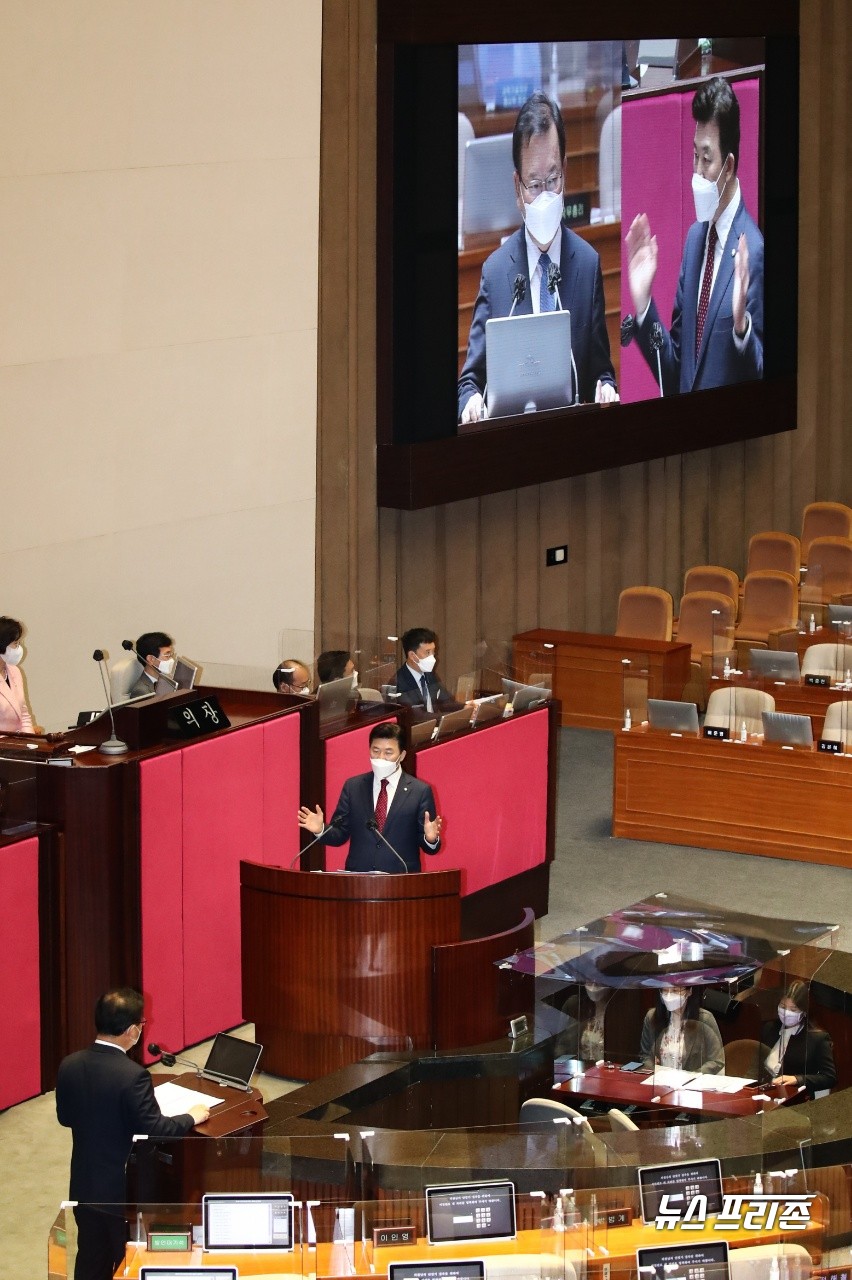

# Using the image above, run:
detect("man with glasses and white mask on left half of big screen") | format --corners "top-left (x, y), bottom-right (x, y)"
top-left (458, 92), bottom-right (618, 424)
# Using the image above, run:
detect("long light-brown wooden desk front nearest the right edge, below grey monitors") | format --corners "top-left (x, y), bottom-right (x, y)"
top-left (613, 731), bottom-right (852, 867)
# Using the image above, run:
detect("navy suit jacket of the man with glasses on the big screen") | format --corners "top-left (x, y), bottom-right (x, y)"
top-left (458, 227), bottom-right (615, 417)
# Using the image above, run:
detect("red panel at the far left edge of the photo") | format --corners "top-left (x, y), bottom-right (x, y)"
top-left (0, 837), bottom-right (41, 1110)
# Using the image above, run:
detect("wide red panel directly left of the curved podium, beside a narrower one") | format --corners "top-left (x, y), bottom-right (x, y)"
top-left (182, 724), bottom-right (263, 1044)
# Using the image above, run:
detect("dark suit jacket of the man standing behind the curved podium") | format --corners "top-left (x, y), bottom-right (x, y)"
top-left (322, 771), bottom-right (441, 874)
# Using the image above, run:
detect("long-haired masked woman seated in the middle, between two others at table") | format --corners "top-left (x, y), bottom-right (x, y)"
top-left (640, 987), bottom-right (725, 1075)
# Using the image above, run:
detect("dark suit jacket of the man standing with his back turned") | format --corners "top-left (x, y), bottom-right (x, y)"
top-left (56, 1044), bottom-right (194, 1204)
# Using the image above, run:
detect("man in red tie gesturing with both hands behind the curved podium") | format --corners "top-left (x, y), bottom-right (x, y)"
top-left (299, 723), bottom-right (444, 874)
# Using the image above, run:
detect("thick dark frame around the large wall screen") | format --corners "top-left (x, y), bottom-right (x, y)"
top-left (376, 0), bottom-right (800, 509)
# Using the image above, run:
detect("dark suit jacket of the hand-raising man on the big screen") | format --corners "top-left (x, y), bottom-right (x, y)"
top-left (637, 200), bottom-right (764, 396)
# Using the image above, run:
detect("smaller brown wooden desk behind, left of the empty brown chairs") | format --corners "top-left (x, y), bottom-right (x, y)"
top-left (512, 628), bottom-right (691, 730)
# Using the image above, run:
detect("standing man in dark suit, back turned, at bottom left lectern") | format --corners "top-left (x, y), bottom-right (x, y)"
top-left (56, 987), bottom-right (210, 1280)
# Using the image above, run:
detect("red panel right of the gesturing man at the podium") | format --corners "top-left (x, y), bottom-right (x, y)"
top-left (417, 710), bottom-right (548, 905)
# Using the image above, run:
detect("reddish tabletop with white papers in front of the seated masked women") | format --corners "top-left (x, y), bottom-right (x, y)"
top-left (554, 1066), bottom-right (798, 1124)
